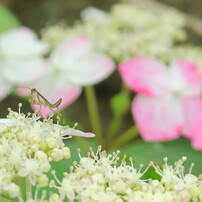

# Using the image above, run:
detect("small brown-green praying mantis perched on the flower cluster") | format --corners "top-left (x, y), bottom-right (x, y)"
top-left (28, 88), bottom-right (62, 115)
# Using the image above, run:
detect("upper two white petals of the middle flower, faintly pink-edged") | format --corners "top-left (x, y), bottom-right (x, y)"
top-left (50, 36), bottom-right (115, 85)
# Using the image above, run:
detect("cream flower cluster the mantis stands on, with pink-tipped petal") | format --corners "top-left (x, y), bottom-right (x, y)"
top-left (0, 104), bottom-right (94, 201)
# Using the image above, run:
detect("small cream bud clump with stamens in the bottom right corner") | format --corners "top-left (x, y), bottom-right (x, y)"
top-left (153, 157), bottom-right (202, 201)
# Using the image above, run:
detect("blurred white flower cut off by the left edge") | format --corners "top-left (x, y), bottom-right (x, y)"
top-left (0, 27), bottom-right (48, 99)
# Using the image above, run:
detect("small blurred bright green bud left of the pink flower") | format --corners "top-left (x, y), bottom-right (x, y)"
top-left (111, 93), bottom-right (130, 116)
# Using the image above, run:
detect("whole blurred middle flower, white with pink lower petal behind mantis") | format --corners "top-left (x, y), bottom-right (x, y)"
top-left (21, 36), bottom-right (115, 115)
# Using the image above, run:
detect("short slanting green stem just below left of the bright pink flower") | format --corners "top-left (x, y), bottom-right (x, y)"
top-left (111, 126), bottom-right (138, 147)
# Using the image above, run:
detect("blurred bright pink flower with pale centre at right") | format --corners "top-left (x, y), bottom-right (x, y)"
top-left (119, 57), bottom-right (202, 149)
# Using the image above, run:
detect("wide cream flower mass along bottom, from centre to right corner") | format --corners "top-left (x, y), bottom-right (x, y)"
top-left (50, 148), bottom-right (202, 202)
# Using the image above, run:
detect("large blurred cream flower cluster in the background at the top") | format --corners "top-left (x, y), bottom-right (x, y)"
top-left (43, 3), bottom-right (185, 62)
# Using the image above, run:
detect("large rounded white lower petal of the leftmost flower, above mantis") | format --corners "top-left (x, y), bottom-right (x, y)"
top-left (3, 57), bottom-right (48, 86)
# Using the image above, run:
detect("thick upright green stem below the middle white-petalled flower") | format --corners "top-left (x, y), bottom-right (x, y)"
top-left (85, 86), bottom-right (102, 144)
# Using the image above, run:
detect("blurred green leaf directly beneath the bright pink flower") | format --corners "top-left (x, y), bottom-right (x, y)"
top-left (121, 138), bottom-right (202, 174)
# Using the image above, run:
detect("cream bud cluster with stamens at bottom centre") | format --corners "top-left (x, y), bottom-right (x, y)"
top-left (51, 147), bottom-right (149, 202)
